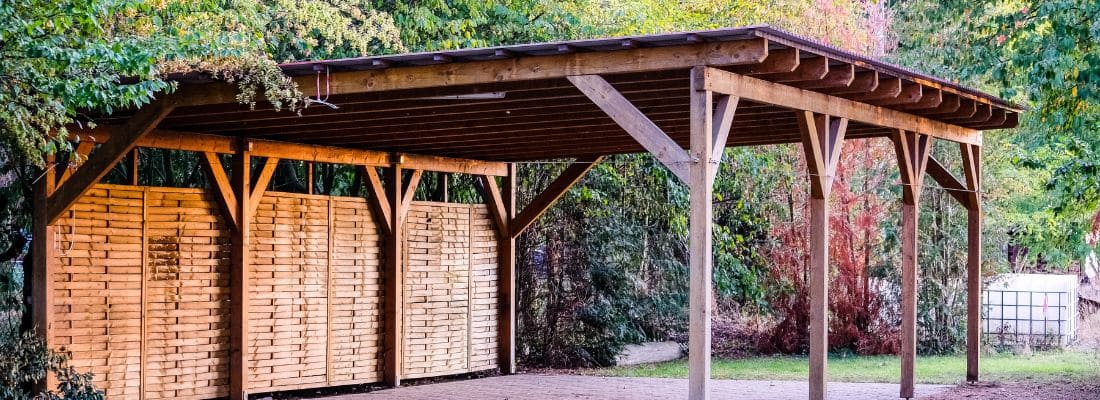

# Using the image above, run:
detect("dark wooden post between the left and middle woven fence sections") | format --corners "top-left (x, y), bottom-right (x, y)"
top-left (228, 141), bottom-right (252, 400)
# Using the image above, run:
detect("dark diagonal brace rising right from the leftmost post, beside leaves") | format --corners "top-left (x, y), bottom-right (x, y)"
top-left (46, 96), bottom-right (178, 224)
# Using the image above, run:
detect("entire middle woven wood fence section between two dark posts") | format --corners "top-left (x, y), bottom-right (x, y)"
top-left (248, 192), bottom-right (382, 391)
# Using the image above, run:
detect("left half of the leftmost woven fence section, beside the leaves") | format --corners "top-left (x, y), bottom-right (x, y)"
top-left (53, 186), bottom-right (144, 399)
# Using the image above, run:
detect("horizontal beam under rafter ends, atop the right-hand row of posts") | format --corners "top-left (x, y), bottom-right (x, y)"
top-left (706, 68), bottom-right (981, 145)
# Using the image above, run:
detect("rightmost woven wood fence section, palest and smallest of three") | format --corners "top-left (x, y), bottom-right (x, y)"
top-left (404, 202), bottom-right (496, 378)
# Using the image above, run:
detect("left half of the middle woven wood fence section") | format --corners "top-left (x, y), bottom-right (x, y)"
top-left (248, 192), bottom-right (329, 391)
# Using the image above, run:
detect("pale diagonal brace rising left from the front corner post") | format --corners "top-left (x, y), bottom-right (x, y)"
top-left (569, 75), bottom-right (692, 182)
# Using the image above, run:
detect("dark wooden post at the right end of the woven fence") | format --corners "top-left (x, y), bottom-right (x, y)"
top-left (499, 163), bottom-right (517, 374)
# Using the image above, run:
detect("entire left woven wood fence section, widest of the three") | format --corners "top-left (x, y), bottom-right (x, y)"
top-left (51, 185), bottom-right (229, 399)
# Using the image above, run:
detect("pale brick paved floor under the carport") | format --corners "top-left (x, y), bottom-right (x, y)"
top-left (328, 374), bottom-right (952, 400)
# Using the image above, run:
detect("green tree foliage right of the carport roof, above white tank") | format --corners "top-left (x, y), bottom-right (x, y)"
top-left (897, 0), bottom-right (1100, 268)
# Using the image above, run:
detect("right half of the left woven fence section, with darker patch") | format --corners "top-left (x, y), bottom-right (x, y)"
top-left (144, 188), bottom-right (229, 399)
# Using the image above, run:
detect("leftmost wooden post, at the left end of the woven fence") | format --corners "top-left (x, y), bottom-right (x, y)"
top-left (31, 157), bottom-right (58, 389)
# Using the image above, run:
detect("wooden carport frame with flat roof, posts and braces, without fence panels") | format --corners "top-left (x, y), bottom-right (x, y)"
top-left (32, 26), bottom-right (1020, 399)
